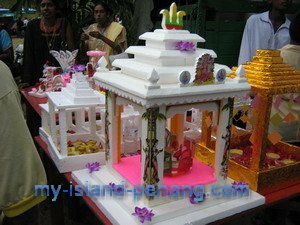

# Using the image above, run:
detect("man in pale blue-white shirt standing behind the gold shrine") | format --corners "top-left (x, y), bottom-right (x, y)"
top-left (238, 0), bottom-right (292, 65)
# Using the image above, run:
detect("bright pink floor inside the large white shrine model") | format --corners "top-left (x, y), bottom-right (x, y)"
top-left (113, 155), bottom-right (216, 186)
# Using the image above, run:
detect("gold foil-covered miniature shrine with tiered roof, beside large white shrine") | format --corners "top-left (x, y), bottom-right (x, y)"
top-left (229, 50), bottom-right (300, 194)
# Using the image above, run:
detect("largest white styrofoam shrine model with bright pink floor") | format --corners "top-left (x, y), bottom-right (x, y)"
top-left (72, 3), bottom-right (264, 224)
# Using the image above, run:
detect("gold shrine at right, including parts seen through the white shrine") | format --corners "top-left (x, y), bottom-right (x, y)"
top-left (195, 50), bottom-right (300, 194)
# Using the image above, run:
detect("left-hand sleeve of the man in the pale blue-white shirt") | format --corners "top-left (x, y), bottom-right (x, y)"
top-left (238, 20), bottom-right (252, 65)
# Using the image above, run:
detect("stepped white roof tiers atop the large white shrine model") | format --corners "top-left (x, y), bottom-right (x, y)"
top-left (113, 29), bottom-right (230, 89)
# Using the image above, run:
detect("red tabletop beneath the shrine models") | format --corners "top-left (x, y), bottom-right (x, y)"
top-left (21, 90), bottom-right (300, 224)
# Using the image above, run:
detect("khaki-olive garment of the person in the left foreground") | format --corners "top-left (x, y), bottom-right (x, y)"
top-left (0, 62), bottom-right (47, 214)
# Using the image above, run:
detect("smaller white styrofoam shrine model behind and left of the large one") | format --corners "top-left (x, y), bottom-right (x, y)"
top-left (40, 72), bottom-right (105, 173)
